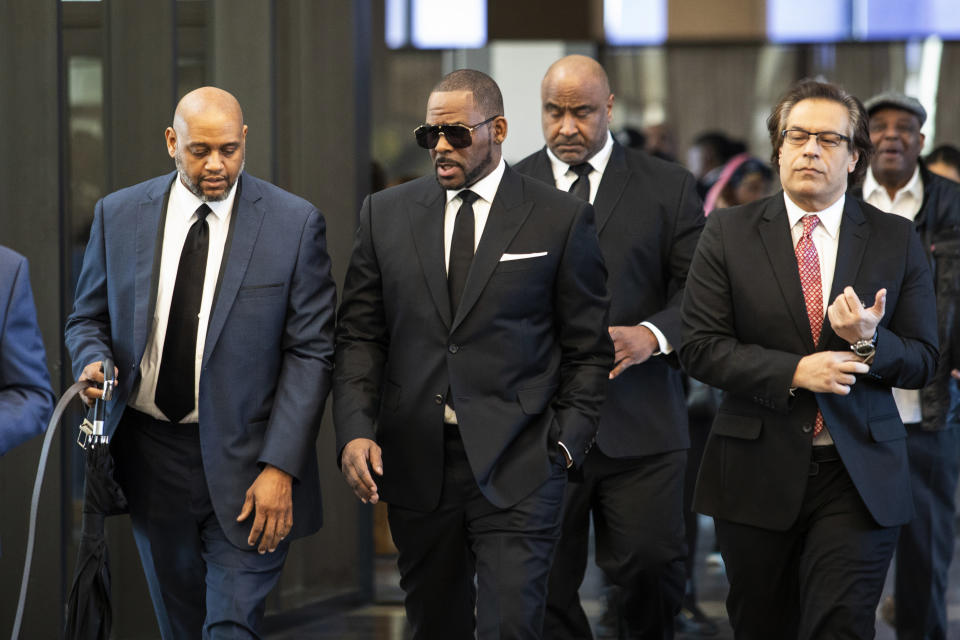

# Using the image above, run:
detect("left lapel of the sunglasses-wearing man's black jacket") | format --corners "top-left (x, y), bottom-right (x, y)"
top-left (409, 185), bottom-right (450, 328)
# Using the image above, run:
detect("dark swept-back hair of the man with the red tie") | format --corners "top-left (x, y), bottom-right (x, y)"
top-left (767, 78), bottom-right (873, 187)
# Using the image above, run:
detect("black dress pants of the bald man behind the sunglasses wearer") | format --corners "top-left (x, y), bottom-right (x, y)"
top-left (543, 447), bottom-right (687, 640)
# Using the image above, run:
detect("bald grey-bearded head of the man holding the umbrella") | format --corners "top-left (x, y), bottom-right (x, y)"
top-left (165, 87), bottom-right (247, 202)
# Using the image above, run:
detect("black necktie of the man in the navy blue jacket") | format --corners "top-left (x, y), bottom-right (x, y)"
top-left (154, 204), bottom-right (210, 422)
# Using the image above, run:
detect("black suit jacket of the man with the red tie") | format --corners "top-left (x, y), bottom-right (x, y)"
top-left (680, 192), bottom-right (938, 530)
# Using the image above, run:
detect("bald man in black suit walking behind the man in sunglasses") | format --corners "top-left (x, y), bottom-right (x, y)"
top-left (517, 56), bottom-right (703, 639)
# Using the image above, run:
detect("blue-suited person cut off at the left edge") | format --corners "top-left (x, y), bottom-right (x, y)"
top-left (0, 247), bottom-right (53, 455)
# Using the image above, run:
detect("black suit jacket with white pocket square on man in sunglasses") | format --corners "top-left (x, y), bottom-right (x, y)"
top-left (334, 168), bottom-right (613, 511)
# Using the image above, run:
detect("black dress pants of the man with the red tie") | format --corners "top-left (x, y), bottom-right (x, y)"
top-left (717, 446), bottom-right (899, 640)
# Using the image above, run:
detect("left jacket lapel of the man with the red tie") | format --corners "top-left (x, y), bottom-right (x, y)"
top-left (760, 198), bottom-right (822, 351)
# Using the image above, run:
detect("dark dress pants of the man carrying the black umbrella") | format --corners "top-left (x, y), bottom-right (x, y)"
top-left (111, 408), bottom-right (289, 640)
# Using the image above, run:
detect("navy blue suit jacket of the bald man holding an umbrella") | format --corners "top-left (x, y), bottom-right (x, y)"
top-left (66, 173), bottom-right (336, 548)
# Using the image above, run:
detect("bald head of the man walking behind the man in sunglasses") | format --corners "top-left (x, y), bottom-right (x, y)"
top-left (540, 56), bottom-right (613, 165)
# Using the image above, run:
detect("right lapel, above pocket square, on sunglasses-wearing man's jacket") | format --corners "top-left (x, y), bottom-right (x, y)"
top-left (452, 167), bottom-right (533, 331)
